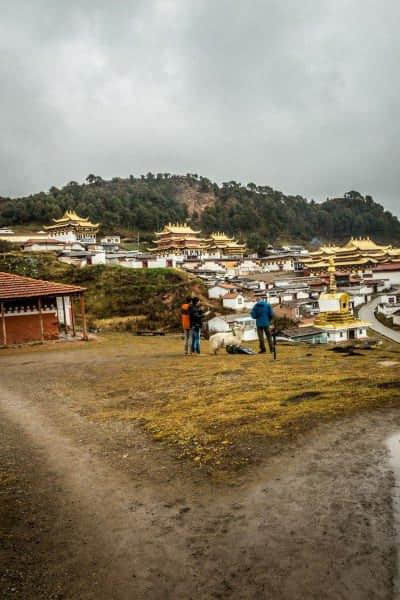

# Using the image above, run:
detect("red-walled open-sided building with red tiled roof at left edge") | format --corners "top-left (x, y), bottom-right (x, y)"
top-left (0, 272), bottom-right (87, 346)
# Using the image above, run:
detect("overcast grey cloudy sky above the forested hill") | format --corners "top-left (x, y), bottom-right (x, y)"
top-left (0, 0), bottom-right (400, 215)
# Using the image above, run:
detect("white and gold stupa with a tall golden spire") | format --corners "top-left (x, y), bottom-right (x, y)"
top-left (314, 256), bottom-right (368, 343)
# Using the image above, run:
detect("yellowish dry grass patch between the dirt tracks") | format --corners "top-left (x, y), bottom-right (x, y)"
top-left (50, 334), bottom-right (400, 468)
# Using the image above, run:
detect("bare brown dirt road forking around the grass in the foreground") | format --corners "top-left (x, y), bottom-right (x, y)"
top-left (0, 344), bottom-right (400, 600)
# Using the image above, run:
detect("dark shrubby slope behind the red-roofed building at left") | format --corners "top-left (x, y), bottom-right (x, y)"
top-left (0, 253), bottom-right (205, 329)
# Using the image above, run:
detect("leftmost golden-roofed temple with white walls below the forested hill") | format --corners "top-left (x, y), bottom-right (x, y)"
top-left (44, 210), bottom-right (99, 244)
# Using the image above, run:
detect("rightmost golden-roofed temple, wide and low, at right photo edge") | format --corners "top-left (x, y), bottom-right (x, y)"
top-left (302, 237), bottom-right (400, 273)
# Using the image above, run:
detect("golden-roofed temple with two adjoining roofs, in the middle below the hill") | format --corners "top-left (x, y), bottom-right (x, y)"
top-left (149, 223), bottom-right (246, 258)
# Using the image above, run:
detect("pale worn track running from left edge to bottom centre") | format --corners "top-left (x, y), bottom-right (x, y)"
top-left (0, 389), bottom-right (200, 599)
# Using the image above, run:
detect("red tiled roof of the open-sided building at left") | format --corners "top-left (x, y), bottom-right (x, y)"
top-left (0, 272), bottom-right (85, 300)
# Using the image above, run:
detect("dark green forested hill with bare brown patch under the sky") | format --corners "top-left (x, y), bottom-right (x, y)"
top-left (0, 173), bottom-right (400, 250)
